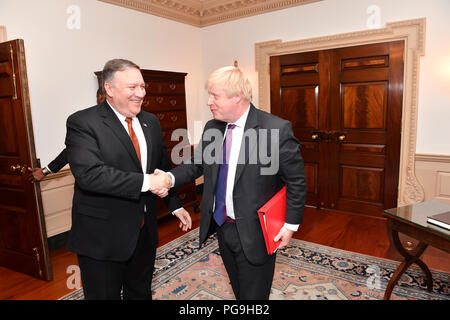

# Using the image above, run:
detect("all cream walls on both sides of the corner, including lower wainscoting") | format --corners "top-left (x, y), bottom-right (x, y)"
top-left (0, 0), bottom-right (450, 236)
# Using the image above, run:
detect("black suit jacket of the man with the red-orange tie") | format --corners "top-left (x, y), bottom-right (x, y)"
top-left (66, 101), bottom-right (181, 261)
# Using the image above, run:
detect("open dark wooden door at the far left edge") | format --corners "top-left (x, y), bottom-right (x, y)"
top-left (0, 40), bottom-right (52, 280)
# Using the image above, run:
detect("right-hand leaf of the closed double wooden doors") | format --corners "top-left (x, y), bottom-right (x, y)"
top-left (330, 42), bottom-right (403, 215)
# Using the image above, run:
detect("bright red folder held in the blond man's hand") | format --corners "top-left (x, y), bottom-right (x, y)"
top-left (258, 187), bottom-right (286, 254)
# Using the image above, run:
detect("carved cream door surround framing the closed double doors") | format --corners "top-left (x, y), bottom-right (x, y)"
top-left (255, 18), bottom-right (426, 205)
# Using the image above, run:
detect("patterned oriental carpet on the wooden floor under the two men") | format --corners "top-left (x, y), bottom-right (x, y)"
top-left (62, 229), bottom-right (450, 300)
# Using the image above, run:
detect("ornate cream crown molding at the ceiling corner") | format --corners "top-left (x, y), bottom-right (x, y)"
top-left (99, 0), bottom-right (322, 27)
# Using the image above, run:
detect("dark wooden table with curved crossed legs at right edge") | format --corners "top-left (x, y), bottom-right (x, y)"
top-left (384, 200), bottom-right (450, 300)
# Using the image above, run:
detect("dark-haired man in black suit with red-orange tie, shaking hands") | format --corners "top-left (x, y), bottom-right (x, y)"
top-left (66, 59), bottom-right (191, 299)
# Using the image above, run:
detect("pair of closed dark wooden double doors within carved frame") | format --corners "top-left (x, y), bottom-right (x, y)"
top-left (271, 41), bottom-right (404, 215)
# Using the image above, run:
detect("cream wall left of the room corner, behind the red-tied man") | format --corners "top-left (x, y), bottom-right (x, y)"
top-left (0, 0), bottom-right (203, 165)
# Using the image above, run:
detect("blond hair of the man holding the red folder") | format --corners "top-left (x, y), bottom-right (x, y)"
top-left (205, 66), bottom-right (252, 102)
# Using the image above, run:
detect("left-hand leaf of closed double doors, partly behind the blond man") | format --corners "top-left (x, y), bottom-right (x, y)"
top-left (271, 52), bottom-right (327, 206)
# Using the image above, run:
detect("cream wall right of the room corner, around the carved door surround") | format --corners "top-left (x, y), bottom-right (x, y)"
top-left (202, 0), bottom-right (450, 155)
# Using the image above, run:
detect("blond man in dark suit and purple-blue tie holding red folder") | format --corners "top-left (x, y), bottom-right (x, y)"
top-left (158, 67), bottom-right (306, 300)
